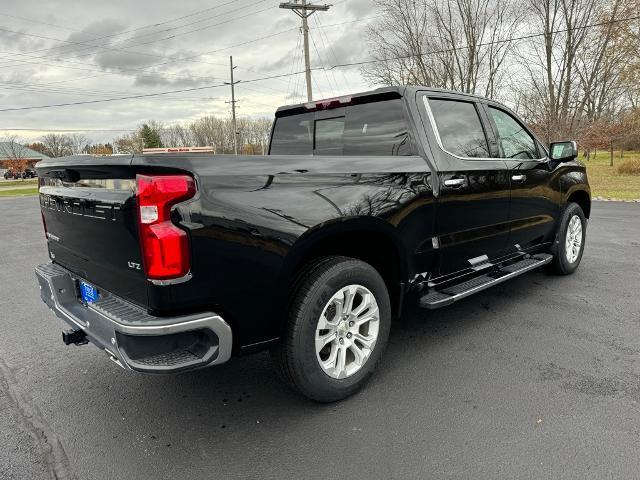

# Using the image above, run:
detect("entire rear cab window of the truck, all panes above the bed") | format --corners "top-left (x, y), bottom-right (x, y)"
top-left (269, 98), bottom-right (412, 156)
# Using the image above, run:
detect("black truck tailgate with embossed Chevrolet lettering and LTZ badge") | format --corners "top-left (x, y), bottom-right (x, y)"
top-left (38, 156), bottom-right (147, 306)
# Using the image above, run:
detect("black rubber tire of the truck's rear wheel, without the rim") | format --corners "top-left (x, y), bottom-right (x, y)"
top-left (271, 256), bottom-right (391, 402)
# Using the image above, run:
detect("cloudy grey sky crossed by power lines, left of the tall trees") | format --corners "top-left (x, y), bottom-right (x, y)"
top-left (0, 0), bottom-right (379, 141)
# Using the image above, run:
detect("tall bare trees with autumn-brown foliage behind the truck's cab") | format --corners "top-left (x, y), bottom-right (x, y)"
top-left (362, 0), bottom-right (640, 153)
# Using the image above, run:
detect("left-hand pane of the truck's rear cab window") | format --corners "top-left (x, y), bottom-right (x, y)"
top-left (269, 113), bottom-right (313, 155)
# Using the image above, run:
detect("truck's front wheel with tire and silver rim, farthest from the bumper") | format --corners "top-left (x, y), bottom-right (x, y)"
top-left (551, 203), bottom-right (587, 275)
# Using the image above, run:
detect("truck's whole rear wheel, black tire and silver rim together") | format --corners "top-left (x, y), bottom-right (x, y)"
top-left (271, 257), bottom-right (391, 402)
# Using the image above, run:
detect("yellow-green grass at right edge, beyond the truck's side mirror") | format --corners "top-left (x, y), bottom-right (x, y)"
top-left (580, 151), bottom-right (640, 200)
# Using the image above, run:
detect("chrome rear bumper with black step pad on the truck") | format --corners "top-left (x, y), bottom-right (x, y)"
top-left (35, 263), bottom-right (232, 373)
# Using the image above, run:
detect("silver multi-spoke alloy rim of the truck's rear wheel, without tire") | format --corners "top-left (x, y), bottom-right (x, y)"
top-left (315, 285), bottom-right (380, 378)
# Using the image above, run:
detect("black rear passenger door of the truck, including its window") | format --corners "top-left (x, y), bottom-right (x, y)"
top-left (423, 93), bottom-right (510, 275)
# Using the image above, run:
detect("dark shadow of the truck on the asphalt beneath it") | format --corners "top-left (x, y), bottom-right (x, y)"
top-left (92, 272), bottom-right (557, 445)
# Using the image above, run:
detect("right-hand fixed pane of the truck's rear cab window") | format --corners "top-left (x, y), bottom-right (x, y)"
top-left (344, 99), bottom-right (411, 156)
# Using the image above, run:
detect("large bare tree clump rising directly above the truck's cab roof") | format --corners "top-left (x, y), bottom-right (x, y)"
top-left (362, 0), bottom-right (522, 97)
